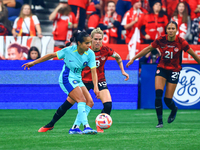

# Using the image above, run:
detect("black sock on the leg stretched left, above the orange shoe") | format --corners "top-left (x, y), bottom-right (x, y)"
top-left (45, 100), bottom-right (73, 127)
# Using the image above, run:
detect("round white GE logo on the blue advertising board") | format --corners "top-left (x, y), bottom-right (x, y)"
top-left (173, 67), bottom-right (200, 106)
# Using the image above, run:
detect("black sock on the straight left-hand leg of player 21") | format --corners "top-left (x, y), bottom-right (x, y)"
top-left (155, 89), bottom-right (163, 124)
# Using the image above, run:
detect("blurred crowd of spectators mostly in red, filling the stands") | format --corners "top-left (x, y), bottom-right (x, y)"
top-left (0, 0), bottom-right (200, 62)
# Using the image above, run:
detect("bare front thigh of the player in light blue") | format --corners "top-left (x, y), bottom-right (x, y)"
top-left (68, 86), bottom-right (86, 103)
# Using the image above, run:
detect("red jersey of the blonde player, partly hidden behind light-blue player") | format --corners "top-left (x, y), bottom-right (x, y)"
top-left (81, 46), bottom-right (114, 83)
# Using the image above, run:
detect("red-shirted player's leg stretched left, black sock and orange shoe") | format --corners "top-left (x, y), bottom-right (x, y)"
top-left (38, 98), bottom-right (75, 132)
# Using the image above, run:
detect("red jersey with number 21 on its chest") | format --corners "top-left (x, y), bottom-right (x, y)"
top-left (151, 35), bottom-right (190, 72)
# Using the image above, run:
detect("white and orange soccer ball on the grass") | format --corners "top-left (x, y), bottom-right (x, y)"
top-left (95, 113), bottom-right (112, 129)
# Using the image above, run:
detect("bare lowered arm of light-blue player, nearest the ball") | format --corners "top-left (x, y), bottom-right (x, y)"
top-left (91, 67), bottom-right (100, 98)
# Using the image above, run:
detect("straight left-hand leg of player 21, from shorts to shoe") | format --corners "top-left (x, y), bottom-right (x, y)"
top-left (155, 72), bottom-right (166, 128)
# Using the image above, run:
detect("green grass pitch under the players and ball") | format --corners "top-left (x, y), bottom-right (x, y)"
top-left (0, 110), bottom-right (200, 150)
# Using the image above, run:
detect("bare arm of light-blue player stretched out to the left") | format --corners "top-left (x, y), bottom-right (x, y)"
top-left (22, 53), bottom-right (57, 70)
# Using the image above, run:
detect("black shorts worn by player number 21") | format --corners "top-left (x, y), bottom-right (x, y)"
top-left (156, 68), bottom-right (180, 84)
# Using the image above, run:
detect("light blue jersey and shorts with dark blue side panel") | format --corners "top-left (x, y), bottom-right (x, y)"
top-left (56, 45), bottom-right (96, 92)
